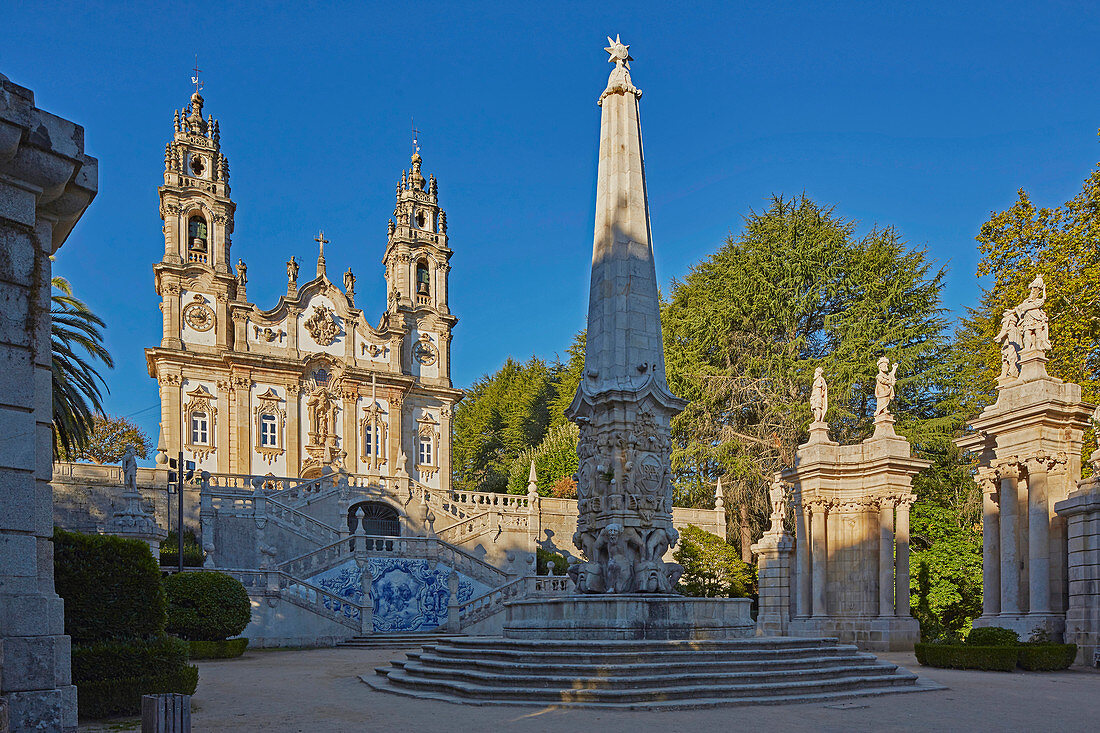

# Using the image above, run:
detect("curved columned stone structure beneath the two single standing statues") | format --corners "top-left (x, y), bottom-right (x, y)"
top-left (783, 414), bottom-right (928, 650)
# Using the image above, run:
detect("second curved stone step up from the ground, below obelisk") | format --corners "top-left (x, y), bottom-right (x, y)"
top-left (403, 663), bottom-right (898, 691)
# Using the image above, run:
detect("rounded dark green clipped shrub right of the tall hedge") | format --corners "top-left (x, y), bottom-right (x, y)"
top-left (164, 572), bottom-right (252, 642)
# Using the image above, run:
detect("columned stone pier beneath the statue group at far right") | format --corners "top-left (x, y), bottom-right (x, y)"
top-left (958, 349), bottom-right (1091, 641)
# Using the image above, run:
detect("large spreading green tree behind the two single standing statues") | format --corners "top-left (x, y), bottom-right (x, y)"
top-left (662, 195), bottom-right (959, 534)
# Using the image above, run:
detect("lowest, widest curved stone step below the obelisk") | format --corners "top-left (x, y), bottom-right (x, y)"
top-left (374, 669), bottom-right (916, 705)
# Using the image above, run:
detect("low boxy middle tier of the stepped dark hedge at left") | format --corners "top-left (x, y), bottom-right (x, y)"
top-left (73, 636), bottom-right (187, 685)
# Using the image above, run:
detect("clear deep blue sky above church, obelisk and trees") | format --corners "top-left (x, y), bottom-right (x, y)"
top-left (0, 0), bottom-right (1100, 453)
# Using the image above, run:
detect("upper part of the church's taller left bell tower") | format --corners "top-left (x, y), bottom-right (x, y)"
top-left (153, 90), bottom-right (237, 349)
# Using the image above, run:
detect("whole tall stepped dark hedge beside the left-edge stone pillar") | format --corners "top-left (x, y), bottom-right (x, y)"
top-left (54, 529), bottom-right (198, 718)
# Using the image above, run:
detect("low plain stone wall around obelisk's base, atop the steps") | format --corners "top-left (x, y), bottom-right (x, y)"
top-left (504, 593), bottom-right (754, 639)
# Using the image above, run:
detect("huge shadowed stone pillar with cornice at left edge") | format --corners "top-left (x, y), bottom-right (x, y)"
top-left (0, 74), bottom-right (98, 731)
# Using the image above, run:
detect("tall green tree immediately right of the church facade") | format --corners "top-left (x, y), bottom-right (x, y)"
top-left (452, 357), bottom-right (556, 492)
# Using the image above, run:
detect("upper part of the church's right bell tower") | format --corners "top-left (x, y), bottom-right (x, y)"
top-left (383, 153), bottom-right (458, 386)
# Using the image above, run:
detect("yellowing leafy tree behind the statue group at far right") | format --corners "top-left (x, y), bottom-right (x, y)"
top-left (957, 154), bottom-right (1100, 470)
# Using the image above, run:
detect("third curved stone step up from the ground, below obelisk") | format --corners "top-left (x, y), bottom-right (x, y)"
top-left (407, 647), bottom-right (879, 677)
